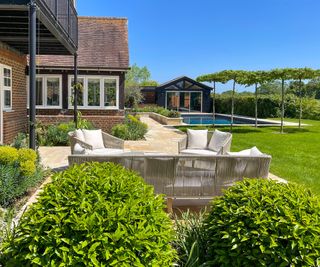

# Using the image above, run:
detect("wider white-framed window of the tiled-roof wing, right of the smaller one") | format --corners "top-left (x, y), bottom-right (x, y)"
top-left (69, 75), bottom-right (119, 109)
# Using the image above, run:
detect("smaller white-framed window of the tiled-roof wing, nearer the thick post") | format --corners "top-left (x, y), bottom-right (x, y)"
top-left (27, 74), bottom-right (62, 109)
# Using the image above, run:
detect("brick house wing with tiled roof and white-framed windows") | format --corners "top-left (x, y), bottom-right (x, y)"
top-left (36, 17), bottom-right (129, 132)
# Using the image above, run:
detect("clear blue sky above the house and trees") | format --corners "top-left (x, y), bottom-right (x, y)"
top-left (77, 0), bottom-right (320, 90)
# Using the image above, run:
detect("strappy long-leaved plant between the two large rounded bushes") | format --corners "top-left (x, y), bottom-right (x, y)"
top-left (173, 210), bottom-right (205, 267)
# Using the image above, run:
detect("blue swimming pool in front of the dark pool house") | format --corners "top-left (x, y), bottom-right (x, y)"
top-left (181, 114), bottom-right (274, 125)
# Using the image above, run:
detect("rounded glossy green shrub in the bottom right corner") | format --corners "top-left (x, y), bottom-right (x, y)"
top-left (204, 179), bottom-right (320, 266)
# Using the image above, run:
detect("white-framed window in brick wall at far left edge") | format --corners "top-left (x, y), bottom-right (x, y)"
top-left (0, 65), bottom-right (12, 110)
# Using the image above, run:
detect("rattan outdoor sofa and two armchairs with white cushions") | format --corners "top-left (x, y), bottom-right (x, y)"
top-left (69, 130), bottom-right (271, 203)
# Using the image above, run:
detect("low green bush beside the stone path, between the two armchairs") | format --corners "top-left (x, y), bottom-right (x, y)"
top-left (112, 115), bottom-right (148, 140)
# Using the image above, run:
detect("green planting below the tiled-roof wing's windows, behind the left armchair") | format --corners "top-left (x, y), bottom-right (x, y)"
top-left (37, 119), bottom-right (93, 146)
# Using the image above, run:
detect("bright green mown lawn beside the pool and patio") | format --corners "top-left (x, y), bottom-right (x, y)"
top-left (179, 119), bottom-right (320, 194)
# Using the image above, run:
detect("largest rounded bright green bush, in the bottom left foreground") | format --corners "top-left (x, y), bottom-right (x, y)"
top-left (1, 163), bottom-right (176, 266)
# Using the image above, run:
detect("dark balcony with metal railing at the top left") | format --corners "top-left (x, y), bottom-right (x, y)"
top-left (0, 0), bottom-right (78, 55)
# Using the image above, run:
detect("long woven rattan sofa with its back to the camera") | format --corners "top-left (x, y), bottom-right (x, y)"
top-left (69, 152), bottom-right (271, 198)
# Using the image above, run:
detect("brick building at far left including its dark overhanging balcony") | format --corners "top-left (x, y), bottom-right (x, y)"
top-left (0, 0), bottom-right (78, 148)
